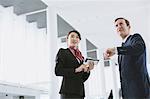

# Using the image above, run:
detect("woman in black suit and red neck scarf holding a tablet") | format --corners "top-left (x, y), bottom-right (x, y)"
top-left (55, 30), bottom-right (94, 99)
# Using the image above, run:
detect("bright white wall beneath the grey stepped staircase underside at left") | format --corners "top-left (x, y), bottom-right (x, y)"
top-left (0, 6), bottom-right (49, 84)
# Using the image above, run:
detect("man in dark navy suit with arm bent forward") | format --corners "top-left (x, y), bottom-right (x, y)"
top-left (105, 18), bottom-right (150, 99)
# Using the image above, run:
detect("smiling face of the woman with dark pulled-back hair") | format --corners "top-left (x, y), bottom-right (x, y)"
top-left (67, 32), bottom-right (80, 47)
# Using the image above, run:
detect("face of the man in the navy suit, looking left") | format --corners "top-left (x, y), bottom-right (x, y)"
top-left (115, 19), bottom-right (130, 39)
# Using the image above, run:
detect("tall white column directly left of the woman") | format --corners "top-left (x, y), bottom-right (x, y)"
top-left (47, 7), bottom-right (60, 99)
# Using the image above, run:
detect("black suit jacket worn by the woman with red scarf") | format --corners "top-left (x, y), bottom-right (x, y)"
top-left (55, 48), bottom-right (90, 97)
